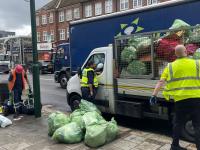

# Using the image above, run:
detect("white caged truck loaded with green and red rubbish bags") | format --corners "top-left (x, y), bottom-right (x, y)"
top-left (67, 26), bottom-right (200, 140)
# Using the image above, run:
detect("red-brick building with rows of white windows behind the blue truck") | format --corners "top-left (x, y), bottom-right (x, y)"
top-left (36, 0), bottom-right (170, 50)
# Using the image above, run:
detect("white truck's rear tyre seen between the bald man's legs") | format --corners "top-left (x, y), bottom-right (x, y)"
top-left (182, 119), bottom-right (195, 142)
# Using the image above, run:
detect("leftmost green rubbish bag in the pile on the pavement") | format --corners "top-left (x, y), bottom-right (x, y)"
top-left (48, 111), bottom-right (70, 136)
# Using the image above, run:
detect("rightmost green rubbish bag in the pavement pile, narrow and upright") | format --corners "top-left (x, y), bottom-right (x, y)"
top-left (106, 118), bottom-right (119, 142)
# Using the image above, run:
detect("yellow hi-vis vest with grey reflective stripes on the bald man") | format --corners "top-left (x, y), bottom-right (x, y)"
top-left (163, 57), bottom-right (200, 102)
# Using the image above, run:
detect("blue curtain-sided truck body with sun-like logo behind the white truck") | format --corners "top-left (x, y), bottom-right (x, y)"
top-left (70, 0), bottom-right (200, 71)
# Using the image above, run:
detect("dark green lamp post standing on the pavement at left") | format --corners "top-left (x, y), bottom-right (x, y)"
top-left (30, 0), bottom-right (42, 118)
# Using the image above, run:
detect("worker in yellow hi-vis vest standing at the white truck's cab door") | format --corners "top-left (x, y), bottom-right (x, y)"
top-left (81, 61), bottom-right (98, 101)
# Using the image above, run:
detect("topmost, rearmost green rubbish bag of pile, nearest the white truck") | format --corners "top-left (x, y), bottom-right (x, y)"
top-left (79, 99), bottom-right (101, 114)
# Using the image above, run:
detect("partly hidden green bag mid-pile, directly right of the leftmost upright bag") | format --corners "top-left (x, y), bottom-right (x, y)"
top-left (70, 109), bottom-right (86, 129)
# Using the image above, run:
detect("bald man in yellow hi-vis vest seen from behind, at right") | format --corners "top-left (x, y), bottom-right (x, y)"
top-left (150, 45), bottom-right (200, 150)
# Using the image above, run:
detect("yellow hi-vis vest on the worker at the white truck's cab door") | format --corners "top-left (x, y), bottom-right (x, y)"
top-left (81, 68), bottom-right (98, 88)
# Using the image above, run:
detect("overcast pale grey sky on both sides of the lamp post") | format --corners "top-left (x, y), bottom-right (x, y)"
top-left (0, 0), bottom-right (50, 35)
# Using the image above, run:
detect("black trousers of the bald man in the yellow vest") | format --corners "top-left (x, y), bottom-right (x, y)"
top-left (172, 98), bottom-right (200, 150)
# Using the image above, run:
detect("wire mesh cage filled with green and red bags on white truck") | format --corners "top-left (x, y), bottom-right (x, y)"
top-left (114, 25), bottom-right (200, 79)
